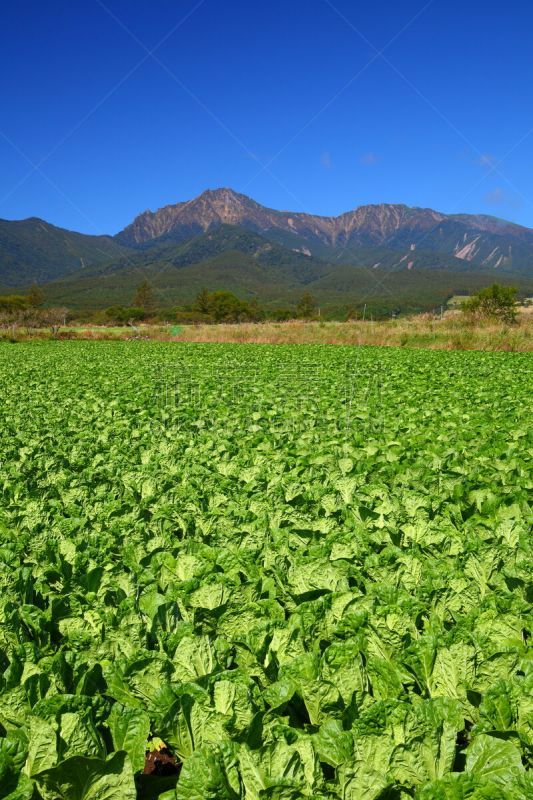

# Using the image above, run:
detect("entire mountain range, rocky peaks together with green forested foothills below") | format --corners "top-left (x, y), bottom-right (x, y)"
top-left (0, 189), bottom-right (533, 310)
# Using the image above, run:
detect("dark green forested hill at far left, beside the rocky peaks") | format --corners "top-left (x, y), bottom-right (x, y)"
top-left (0, 217), bottom-right (132, 286)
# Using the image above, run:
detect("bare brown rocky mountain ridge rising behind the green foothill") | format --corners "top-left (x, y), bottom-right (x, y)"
top-left (115, 189), bottom-right (533, 275)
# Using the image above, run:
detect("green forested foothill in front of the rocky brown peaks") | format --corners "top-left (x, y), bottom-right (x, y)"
top-left (40, 225), bottom-right (533, 314)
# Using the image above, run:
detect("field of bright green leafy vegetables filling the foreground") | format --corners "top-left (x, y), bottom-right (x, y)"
top-left (0, 341), bottom-right (533, 800)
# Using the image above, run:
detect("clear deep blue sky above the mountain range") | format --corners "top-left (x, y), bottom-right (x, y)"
top-left (0, 0), bottom-right (533, 233)
